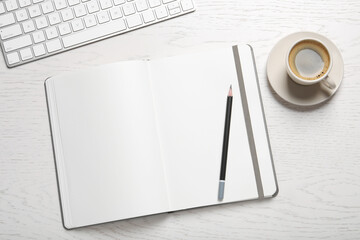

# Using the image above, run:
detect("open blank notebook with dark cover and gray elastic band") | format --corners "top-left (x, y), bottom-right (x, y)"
top-left (45, 45), bottom-right (277, 229)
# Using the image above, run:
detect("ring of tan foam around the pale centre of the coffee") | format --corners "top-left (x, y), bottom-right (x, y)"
top-left (289, 40), bottom-right (330, 80)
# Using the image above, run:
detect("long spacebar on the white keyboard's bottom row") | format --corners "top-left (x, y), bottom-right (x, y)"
top-left (62, 19), bottom-right (126, 48)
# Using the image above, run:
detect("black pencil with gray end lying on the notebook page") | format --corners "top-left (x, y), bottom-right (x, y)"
top-left (218, 85), bottom-right (233, 201)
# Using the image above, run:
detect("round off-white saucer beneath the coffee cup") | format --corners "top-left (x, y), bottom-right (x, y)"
top-left (266, 32), bottom-right (344, 106)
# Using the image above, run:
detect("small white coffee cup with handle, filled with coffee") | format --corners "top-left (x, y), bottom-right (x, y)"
top-left (285, 38), bottom-right (336, 89)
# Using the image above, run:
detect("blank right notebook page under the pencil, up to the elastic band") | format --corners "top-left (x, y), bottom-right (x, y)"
top-left (150, 47), bottom-right (258, 210)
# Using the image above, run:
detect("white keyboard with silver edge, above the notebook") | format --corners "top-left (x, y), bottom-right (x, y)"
top-left (0, 0), bottom-right (195, 67)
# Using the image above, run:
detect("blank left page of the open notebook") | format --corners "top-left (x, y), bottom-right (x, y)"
top-left (46, 62), bottom-right (169, 228)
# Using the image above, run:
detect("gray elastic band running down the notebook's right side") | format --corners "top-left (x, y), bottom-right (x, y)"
top-left (233, 46), bottom-right (264, 198)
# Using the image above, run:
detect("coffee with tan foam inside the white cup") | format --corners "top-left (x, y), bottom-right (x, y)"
top-left (288, 39), bottom-right (330, 81)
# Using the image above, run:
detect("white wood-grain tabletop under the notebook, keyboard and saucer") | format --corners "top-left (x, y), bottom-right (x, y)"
top-left (0, 0), bottom-right (360, 240)
